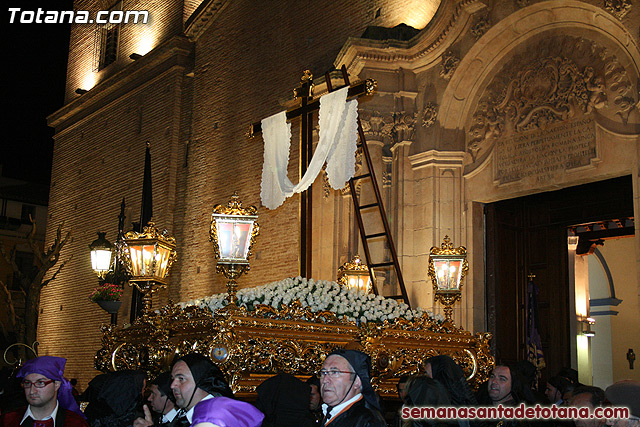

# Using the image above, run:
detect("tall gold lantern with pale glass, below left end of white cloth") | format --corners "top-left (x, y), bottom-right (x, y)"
top-left (209, 191), bottom-right (260, 307)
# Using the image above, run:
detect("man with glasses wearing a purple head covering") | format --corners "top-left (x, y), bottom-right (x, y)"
top-left (0, 356), bottom-right (89, 427)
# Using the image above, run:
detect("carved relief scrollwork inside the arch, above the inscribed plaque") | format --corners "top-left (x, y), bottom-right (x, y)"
top-left (467, 36), bottom-right (636, 158)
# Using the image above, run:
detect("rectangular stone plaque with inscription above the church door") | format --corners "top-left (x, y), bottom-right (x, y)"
top-left (494, 117), bottom-right (597, 185)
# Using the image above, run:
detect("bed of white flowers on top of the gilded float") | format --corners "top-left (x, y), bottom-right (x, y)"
top-left (179, 277), bottom-right (445, 323)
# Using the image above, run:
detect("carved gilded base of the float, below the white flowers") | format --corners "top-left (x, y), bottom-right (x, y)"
top-left (95, 301), bottom-right (493, 397)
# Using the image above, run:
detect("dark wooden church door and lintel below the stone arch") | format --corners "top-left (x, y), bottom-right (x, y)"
top-left (485, 176), bottom-right (633, 390)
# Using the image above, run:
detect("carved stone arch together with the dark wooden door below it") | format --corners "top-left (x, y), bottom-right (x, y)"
top-left (450, 1), bottom-right (640, 378)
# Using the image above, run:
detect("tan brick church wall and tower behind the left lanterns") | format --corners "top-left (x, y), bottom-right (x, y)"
top-left (39, 0), bottom-right (432, 388)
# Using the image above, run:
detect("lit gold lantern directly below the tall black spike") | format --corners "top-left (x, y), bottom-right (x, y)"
top-left (124, 221), bottom-right (177, 314)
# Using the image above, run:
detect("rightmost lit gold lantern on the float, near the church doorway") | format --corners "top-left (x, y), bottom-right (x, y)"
top-left (429, 236), bottom-right (469, 321)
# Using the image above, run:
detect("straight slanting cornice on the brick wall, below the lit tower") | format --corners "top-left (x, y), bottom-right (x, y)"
top-left (47, 36), bottom-right (193, 135)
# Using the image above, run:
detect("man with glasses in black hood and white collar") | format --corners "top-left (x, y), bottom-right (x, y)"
top-left (318, 350), bottom-right (387, 427)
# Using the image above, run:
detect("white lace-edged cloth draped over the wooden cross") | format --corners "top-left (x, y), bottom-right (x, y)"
top-left (260, 87), bottom-right (358, 209)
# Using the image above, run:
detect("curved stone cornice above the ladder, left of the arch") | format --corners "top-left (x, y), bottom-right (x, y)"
top-left (335, 0), bottom-right (487, 75)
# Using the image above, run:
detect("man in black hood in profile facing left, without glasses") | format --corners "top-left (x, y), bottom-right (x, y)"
top-left (171, 353), bottom-right (233, 427)
